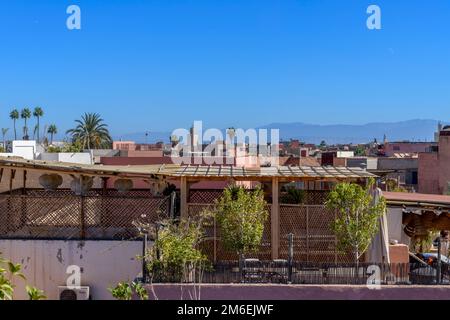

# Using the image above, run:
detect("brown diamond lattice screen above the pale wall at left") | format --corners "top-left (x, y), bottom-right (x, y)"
top-left (0, 190), bottom-right (170, 240)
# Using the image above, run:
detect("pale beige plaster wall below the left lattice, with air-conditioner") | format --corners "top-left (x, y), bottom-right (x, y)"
top-left (0, 240), bottom-right (142, 300)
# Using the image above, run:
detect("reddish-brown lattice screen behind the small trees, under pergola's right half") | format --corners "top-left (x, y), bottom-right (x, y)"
top-left (188, 203), bottom-right (353, 263)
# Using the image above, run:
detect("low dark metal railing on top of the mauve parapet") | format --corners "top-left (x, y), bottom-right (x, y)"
top-left (152, 259), bottom-right (450, 285)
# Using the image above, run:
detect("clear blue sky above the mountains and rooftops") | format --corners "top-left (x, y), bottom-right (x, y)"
top-left (0, 0), bottom-right (450, 134)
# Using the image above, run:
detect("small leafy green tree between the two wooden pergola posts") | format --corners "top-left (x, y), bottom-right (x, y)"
top-left (216, 185), bottom-right (269, 273)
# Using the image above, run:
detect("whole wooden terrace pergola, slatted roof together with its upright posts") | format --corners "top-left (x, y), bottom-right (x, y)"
top-left (0, 157), bottom-right (376, 259)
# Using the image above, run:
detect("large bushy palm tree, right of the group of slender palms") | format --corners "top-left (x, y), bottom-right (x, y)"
top-left (66, 113), bottom-right (112, 149)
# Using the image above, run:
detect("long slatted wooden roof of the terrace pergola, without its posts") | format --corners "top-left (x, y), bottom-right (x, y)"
top-left (0, 157), bottom-right (374, 181)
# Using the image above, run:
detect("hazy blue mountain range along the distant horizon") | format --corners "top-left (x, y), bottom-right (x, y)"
top-left (114, 119), bottom-right (438, 144)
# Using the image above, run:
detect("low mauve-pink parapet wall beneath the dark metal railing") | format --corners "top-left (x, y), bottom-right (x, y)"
top-left (147, 284), bottom-right (450, 300)
